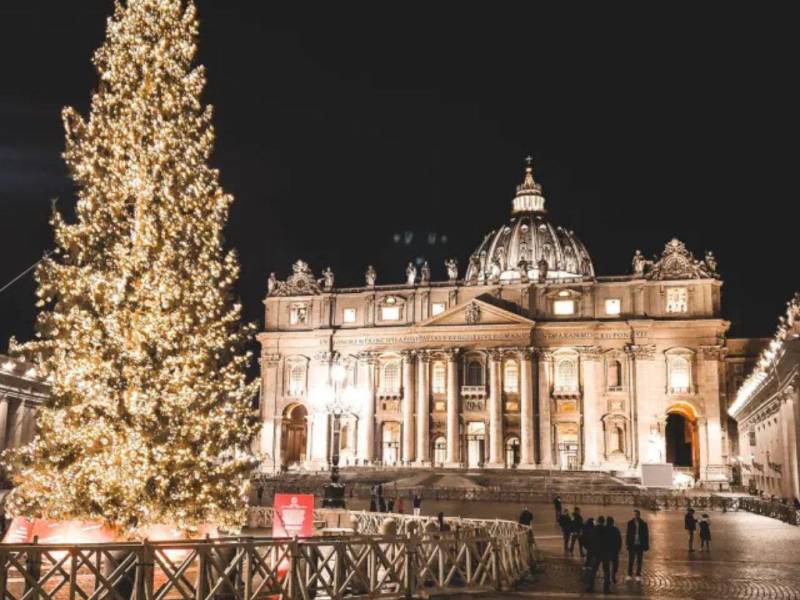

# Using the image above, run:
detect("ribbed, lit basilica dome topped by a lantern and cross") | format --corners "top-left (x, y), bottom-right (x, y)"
top-left (466, 159), bottom-right (594, 283)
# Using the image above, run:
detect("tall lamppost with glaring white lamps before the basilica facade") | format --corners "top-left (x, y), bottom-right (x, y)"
top-left (309, 363), bottom-right (366, 508)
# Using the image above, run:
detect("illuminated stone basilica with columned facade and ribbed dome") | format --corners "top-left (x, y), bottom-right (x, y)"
top-left (258, 165), bottom-right (748, 487)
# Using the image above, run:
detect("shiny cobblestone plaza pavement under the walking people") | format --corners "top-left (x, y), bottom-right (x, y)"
top-left (351, 501), bottom-right (800, 600)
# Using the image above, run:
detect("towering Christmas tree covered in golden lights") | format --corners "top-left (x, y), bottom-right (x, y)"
top-left (4, 0), bottom-right (257, 535)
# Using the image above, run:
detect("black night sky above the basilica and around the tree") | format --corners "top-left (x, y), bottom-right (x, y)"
top-left (0, 0), bottom-right (800, 351)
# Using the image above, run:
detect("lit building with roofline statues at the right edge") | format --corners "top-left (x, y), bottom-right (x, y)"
top-left (728, 292), bottom-right (800, 501)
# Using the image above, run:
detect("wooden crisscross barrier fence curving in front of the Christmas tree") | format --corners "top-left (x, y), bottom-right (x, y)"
top-left (0, 513), bottom-right (536, 600)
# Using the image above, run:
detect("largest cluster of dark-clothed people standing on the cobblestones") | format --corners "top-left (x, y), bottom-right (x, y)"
top-left (553, 497), bottom-right (650, 593)
